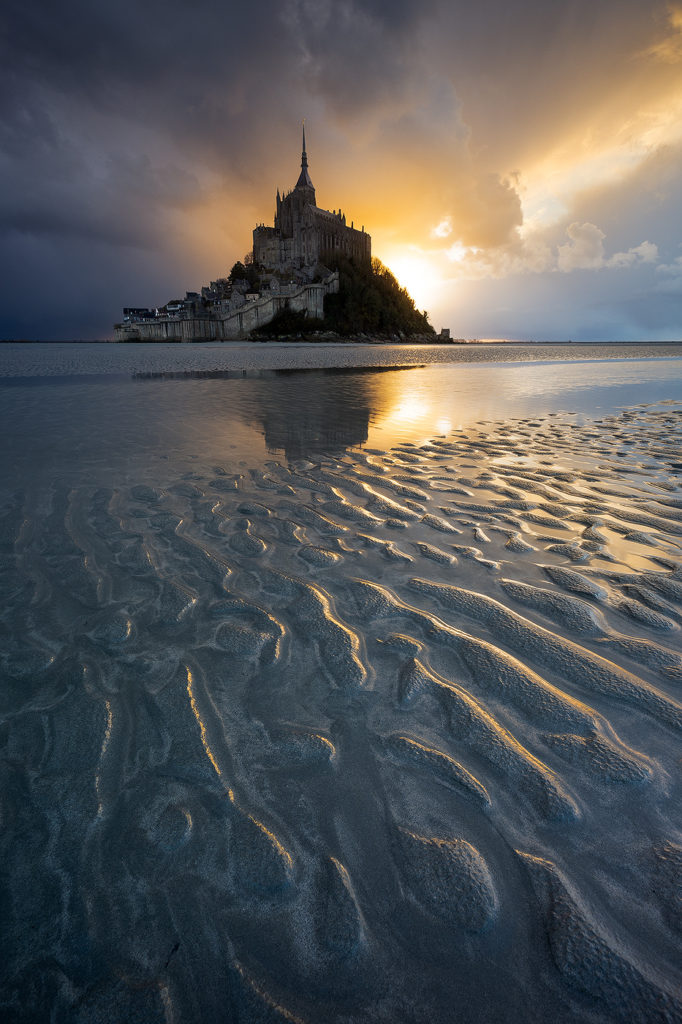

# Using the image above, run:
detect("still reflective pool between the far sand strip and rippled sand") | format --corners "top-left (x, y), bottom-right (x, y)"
top-left (0, 359), bottom-right (682, 486)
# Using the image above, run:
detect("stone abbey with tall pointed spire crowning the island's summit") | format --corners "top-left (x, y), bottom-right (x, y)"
top-left (253, 126), bottom-right (372, 275)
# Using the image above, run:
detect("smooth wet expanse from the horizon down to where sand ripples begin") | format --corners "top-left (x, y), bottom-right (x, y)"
top-left (0, 344), bottom-right (682, 485)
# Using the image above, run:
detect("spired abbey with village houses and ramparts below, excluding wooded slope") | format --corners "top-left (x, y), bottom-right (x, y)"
top-left (114, 129), bottom-right (372, 341)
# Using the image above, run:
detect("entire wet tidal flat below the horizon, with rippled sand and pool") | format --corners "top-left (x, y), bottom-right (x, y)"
top-left (0, 344), bottom-right (682, 1024)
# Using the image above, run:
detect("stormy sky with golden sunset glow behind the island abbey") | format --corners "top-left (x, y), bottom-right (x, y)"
top-left (0, 0), bottom-right (682, 340)
